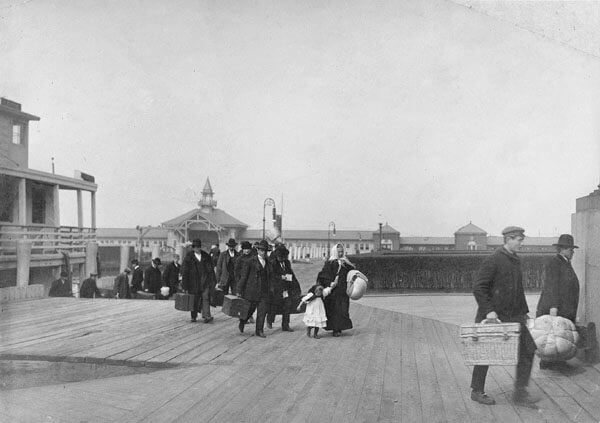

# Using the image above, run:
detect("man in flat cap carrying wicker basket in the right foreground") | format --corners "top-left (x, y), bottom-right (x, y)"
top-left (471, 226), bottom-right (537, 405)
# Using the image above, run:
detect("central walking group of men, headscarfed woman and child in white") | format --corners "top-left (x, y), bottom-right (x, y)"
top-left (181, 239), bottom-right (354, 338)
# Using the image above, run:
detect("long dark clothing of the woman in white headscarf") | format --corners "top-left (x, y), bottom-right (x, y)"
top-left (317, 260), bottom-right (354, 331)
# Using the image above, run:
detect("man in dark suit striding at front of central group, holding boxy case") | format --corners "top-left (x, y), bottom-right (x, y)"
top-left (236, 239), bottom-right (273, 338)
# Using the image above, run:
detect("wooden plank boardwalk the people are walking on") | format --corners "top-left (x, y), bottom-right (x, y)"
top-left (0, 298), bottom-right (600, 423)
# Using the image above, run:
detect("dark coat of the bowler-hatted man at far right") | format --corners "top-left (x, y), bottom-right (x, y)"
top-left (536, 254), bottom-right (579, 322)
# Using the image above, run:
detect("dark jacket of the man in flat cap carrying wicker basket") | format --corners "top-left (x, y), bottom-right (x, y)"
top-left (473, 247), bottom-right (529, 323)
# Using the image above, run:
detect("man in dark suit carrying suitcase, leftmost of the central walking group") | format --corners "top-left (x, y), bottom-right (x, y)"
top-left (181, 239), bottom-right (216, 323)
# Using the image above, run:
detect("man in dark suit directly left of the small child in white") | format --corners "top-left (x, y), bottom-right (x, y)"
top-left (267, 244), bottom-right (300, 332)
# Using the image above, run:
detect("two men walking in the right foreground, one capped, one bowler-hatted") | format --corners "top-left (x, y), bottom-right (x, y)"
top-left (471, 226), bottom-right (579, 405)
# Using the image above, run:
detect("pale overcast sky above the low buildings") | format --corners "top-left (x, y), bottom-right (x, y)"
top-left (0, 0), bottom-right (600, 236)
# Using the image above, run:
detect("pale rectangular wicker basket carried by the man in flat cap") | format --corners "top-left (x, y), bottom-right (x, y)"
top-left (460, 323), bottom-right (521, 366)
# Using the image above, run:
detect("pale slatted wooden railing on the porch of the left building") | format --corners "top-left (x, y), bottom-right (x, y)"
top-left (0, 224), bottom-right (96, 255)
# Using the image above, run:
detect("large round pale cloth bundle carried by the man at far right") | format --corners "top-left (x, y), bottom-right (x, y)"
top-left (529, 315), bottom-right (579, 361)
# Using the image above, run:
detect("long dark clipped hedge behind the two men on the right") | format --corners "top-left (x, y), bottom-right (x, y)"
top-left (350, 252), bottom-right (553, 292)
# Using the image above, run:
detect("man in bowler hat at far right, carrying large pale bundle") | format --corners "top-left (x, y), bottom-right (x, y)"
top-left (536, 234), bottom-right (579, 369)
